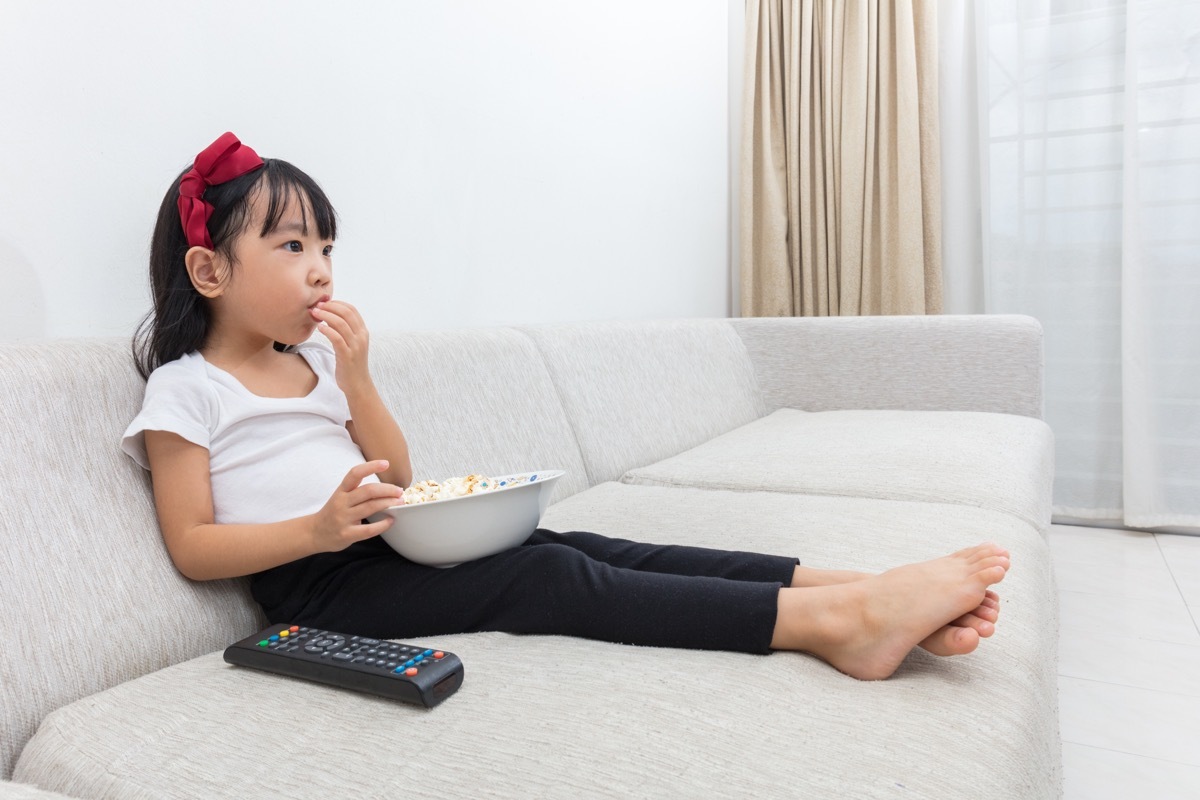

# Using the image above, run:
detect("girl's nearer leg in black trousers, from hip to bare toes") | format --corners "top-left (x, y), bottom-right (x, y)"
top-left (253, 541), bottom-right (1009, 679)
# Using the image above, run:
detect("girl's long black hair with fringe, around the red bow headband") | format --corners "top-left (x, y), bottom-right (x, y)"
top-left (133, 158), bottom-right (337, 379)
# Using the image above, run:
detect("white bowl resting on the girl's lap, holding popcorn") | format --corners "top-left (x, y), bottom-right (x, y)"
top-left (368, 469), bottom-right (565, 567)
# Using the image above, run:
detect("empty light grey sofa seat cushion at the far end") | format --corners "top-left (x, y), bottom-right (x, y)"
top-left (620, 409), bottom-right (1054, 530)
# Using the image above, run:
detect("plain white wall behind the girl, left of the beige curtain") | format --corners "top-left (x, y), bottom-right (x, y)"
top-left (0, 0), bottom-right (740, 341)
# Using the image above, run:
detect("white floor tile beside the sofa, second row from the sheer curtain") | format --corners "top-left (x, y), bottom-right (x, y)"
top-left (1058, 591), bottom-right (1200, 645)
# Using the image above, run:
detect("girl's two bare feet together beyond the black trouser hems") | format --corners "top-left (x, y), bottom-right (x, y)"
top-left (772, 545), bottom-right (1009, 680)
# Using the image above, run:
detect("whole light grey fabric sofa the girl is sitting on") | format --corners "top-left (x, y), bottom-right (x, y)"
top-left (0, 315), bottom-right (1062, 800)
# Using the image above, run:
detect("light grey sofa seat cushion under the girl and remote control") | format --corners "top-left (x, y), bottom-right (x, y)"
top-left (16, 483), bottom-right (1060, 799)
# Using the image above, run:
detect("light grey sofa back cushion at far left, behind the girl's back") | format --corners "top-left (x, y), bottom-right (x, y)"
top-left (0, 338), bottom-right (262, 777)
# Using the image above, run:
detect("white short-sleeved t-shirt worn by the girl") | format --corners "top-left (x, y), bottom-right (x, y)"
top-left (121, 339), bottom-right (379, 523)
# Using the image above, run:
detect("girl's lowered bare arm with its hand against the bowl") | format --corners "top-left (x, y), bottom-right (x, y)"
top-left (145, 431), bottom-right (400, 581)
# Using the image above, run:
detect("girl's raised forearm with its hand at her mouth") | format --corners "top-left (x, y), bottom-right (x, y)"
top-left (312, 300), bottom-right (413, 487)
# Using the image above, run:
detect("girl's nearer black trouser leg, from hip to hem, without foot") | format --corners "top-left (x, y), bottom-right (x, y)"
top-left (267, 537), bottom-right (794, 654)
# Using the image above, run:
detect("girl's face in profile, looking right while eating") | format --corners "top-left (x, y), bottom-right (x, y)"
top-left (214, 191), bottom-right (334, 344)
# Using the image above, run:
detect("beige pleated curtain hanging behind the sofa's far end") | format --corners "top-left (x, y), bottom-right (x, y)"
top-left (740, 0), bottom-right (942, 317)
